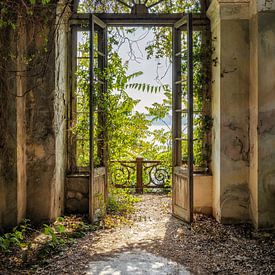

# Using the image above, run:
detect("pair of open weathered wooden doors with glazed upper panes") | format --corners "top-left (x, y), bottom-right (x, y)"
top-left (89, 14), bottom-right (196, 222)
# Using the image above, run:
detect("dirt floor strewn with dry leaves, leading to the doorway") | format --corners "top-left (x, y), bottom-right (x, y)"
top-left (0, 194), bottom-right (275, 274)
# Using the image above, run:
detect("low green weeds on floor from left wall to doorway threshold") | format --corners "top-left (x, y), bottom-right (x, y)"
top-left (0, 189), bottom-right (140, 269)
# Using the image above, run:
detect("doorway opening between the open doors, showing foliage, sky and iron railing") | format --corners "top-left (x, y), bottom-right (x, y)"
top-left (109, 26), bottom-right (172, 193)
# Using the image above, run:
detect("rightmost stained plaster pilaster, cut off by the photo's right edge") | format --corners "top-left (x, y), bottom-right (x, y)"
top-left (249, 0), bottom-right (275, 228)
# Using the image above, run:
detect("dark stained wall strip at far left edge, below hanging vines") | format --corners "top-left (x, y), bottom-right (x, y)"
top-left (0, 29), bottom-right (18, 230)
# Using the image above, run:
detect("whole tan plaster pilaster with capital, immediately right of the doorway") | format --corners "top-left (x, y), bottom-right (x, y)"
top-left (207, 0), bottom-right (249, 223)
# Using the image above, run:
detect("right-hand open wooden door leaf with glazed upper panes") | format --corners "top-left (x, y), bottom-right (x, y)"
top-left (172, 14), bottom-right (193, 223)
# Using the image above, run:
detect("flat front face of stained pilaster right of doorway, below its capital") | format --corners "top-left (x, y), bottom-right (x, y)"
top-left (220, 19), bottom-right (252, 222)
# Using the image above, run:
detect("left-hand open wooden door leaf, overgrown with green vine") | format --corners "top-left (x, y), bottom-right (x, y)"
top-left (89, 14), bottom-right (108, 222)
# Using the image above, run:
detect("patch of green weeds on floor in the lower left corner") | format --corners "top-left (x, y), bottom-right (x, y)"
top-left (0, 216), bottom-right (101, 267)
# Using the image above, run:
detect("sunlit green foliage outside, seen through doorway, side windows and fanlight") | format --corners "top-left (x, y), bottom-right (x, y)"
top-left (72, 0), bottom-right (212, 189)
